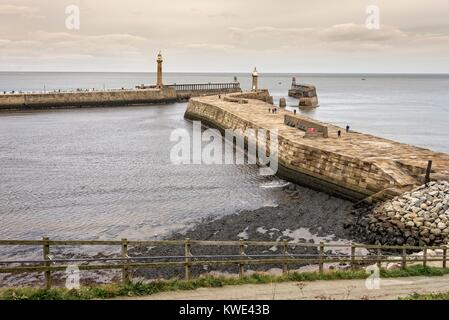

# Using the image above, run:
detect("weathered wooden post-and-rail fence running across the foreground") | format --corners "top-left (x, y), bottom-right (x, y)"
top-left (0, 237), bottom-right (447, 288)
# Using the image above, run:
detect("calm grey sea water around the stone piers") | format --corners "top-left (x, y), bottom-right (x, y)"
top-left (0, 73), bottom-right (449, 244)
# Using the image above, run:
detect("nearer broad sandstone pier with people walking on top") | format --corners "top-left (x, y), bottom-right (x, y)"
top-left (185, 92), bottom-right (449, 200)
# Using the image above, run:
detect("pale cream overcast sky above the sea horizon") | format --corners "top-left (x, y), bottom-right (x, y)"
top-left (0, 0), bottom-right (449, 73)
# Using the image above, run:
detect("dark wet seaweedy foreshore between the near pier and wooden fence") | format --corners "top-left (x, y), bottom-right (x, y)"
top-left (129, 183), bottom-right (368, 279)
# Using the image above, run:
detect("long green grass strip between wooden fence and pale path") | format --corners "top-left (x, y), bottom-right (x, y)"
top-left (0, 266), bottom-right (449, 300)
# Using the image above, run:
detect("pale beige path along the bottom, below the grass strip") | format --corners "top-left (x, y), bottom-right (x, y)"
top-left (127, 275), bottom-right (449, 300)
